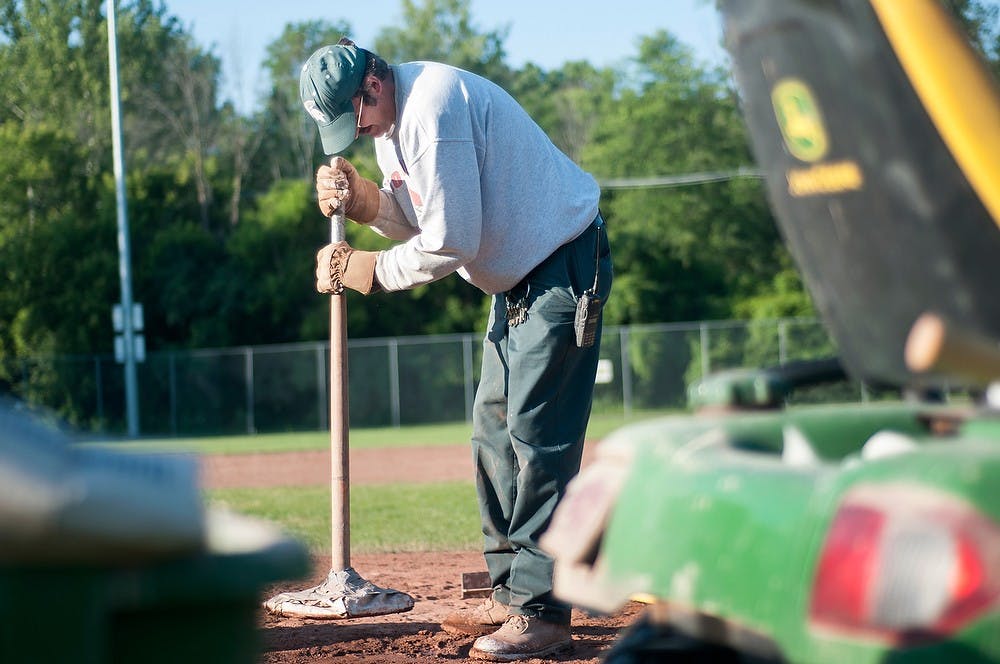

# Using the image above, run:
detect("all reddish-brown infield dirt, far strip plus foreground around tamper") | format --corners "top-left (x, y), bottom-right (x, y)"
top-left (202, 445), bottom-right (641, 664)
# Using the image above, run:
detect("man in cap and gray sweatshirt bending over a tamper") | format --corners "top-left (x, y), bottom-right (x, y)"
top-left (300, 39), bottom-right (612, 661)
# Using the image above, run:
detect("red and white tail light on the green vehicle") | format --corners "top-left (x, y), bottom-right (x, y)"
top-left (810, 485), bottom-right (1000, 642)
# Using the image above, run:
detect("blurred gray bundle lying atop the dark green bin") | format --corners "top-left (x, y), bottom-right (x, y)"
top-left (0, 399), bottom-right (205, 563)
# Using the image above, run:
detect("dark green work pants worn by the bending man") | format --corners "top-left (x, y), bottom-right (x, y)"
top-left (472, 216), bottom-right (612, 624)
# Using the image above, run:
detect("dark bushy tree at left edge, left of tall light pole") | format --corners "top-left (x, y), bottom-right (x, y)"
top-left (0, 123), bottom-right (117, 421)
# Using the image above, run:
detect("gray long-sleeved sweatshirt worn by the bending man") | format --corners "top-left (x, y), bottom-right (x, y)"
top-left (371, 62), bottom-right (600, 294)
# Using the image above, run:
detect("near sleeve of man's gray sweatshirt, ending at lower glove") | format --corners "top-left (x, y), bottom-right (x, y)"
top-left (376, 139), bottom-right (483, 291)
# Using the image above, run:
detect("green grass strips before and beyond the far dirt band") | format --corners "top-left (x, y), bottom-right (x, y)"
top-left (121, 412), bottom-right (676, 553)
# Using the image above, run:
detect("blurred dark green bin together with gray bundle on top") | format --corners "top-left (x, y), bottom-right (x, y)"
top-left (0, 398), bottom-right (310, 664)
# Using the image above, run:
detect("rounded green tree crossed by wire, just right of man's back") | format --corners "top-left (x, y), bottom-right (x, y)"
top-left (583, 32), bottom-right (785, 323)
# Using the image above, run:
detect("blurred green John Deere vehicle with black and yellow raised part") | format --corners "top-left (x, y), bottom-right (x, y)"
top-left (543, 0), bottom-right (1000, 664)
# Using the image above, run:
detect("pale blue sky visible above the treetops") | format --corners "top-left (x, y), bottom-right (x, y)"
top-left (164, 0), bottom-right (726, 110)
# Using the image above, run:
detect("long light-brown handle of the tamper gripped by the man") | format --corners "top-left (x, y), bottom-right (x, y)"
top-left (330, 212), bottom-right (351, 570)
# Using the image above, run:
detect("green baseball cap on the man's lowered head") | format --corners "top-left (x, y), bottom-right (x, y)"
top-left (299, 44), bottom-right (367, 154)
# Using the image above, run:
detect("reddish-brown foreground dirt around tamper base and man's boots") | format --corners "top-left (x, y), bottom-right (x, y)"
top-left (261, 551), bottom-right (641, 664)
